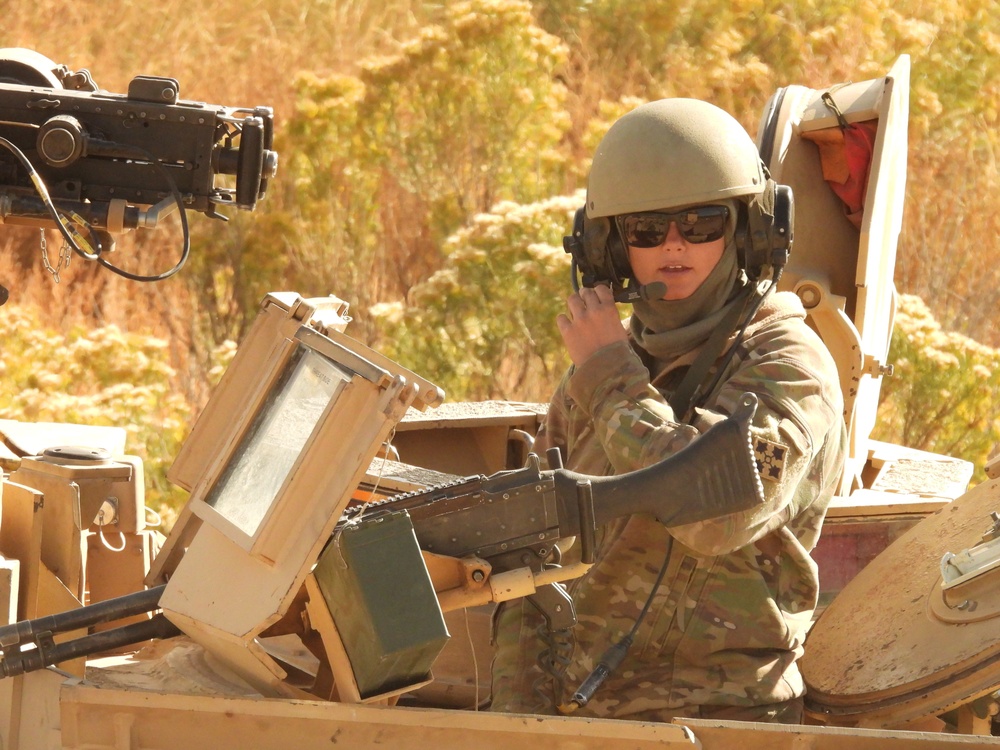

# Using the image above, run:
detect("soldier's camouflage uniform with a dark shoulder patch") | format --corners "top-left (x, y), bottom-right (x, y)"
top-left (493, 293), bottom-right (846, 721)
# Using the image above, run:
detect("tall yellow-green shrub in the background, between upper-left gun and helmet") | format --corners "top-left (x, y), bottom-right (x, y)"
top-left (270, 0), bottom-right (570, 339)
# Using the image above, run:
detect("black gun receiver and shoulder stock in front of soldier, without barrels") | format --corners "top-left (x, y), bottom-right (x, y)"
top-left (335, 394), bottom-right (763, 630)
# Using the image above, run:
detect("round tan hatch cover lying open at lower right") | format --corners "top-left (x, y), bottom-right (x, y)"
top-left (802, 480), bottom-right (1000, 725)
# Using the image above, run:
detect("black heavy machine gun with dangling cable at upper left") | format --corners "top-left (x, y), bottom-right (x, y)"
top-left (0, 49), bottom-right (278, 281)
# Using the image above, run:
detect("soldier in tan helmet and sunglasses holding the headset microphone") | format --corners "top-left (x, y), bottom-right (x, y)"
top-left (493, 99), bottom-right (846, 723)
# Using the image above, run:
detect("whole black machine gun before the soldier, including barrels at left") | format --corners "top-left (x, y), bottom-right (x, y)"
top-left (0, 394), bottom-right (763, 691)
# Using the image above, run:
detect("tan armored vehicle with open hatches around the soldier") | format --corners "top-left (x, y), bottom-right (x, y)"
top-left (0, 50), bottom-right (1000, 750)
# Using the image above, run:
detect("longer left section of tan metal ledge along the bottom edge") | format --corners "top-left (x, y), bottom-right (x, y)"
top-left (61, 684), bottom-right (698, 750)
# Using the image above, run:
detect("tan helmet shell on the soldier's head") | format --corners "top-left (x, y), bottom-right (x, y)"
top-left (587, 99), bottom-right (767, 219)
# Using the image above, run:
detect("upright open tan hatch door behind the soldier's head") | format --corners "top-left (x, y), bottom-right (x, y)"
top-left (758, 55), bottom-right (910, 494)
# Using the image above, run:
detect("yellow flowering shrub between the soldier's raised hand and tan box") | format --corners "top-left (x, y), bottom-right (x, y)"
top-left (371, 191), bottom-right (584, 401)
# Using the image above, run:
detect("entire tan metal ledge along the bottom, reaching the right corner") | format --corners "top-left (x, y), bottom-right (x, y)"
top-left (52, 683), bottom-right (1000, 750)
